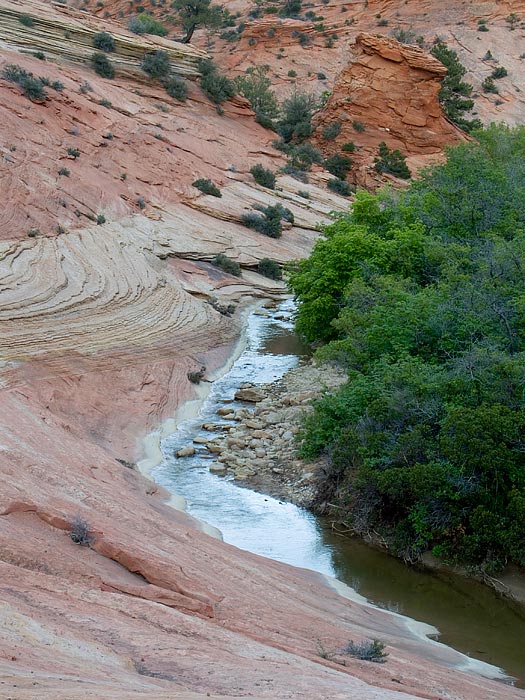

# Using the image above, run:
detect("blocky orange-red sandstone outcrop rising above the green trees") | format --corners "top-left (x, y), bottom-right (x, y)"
top-left (316, 34), bottom-right (466, 185)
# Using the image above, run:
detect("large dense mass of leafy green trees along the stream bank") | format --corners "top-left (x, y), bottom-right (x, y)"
top-left (290, 125), bottom-right (525, 573)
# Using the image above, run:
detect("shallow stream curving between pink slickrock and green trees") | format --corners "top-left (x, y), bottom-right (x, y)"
top-left (153, 302), bottom-right (525, 687)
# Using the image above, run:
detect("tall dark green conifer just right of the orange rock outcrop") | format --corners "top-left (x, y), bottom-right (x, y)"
top-left (431, 39), bottom-right (481, 132)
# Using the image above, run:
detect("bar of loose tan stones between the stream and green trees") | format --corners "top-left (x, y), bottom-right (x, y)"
top-left (190, 361), bottom-right (346, 506)
